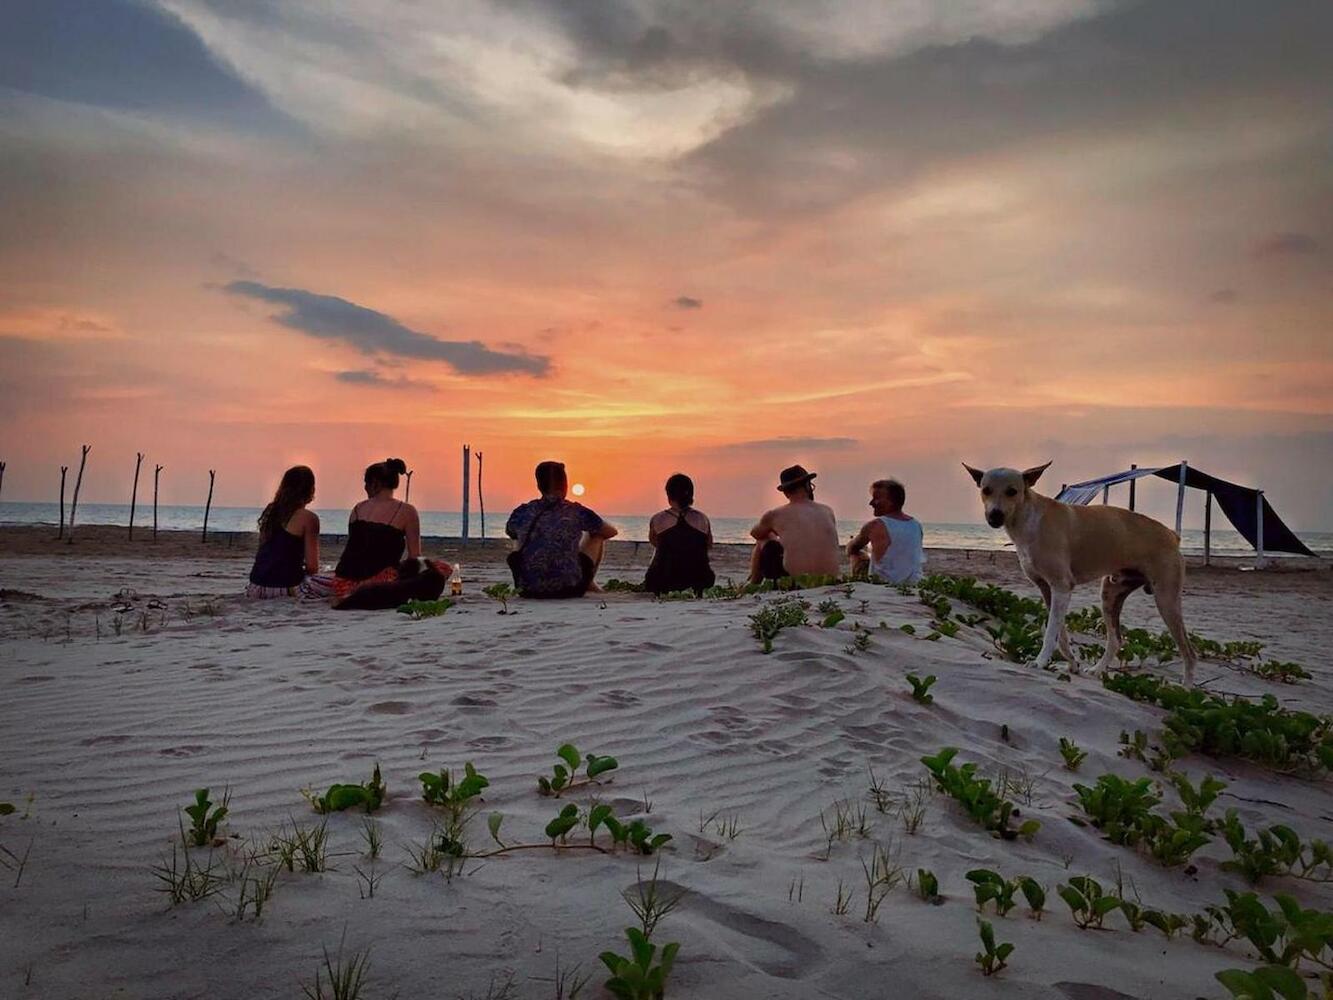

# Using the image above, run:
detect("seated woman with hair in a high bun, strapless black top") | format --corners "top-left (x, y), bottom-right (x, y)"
top-left (311, 459), bottom-right (453, 601)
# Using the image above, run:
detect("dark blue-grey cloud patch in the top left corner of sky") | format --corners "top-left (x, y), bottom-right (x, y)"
top-left (0, 0), bottom-right (293, 128)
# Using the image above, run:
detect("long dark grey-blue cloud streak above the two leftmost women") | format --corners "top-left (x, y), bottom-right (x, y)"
top-left (224, 281), bottom-right (551, 376)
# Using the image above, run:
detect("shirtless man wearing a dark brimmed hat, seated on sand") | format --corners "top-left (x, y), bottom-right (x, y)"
top-left (750, 465), bottom-right (841, 583)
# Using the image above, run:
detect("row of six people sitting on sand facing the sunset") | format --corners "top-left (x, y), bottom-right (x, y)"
top-left (247, 459), bottom-right (925, 608)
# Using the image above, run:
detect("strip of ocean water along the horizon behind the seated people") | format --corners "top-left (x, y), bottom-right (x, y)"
top-left (0, 503), bottom-right (1333, 556)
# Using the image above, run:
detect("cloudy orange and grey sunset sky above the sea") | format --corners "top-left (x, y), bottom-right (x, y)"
top-left (0, 0), bottom-right (1333, 529)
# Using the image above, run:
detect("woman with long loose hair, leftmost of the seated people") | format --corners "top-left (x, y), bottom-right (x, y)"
top-left (245, 465), bottom-right (320, 597)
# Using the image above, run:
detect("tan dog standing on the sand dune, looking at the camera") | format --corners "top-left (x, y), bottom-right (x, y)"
top-left (964, 461), bottom-right (1194, 687)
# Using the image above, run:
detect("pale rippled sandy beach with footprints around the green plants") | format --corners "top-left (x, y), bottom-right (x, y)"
top-left (0, 528), bottom-right (1333, 1000)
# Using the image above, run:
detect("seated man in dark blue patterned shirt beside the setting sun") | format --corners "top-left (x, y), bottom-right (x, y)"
top-left (504, 461), bottom-right (619, 597)
